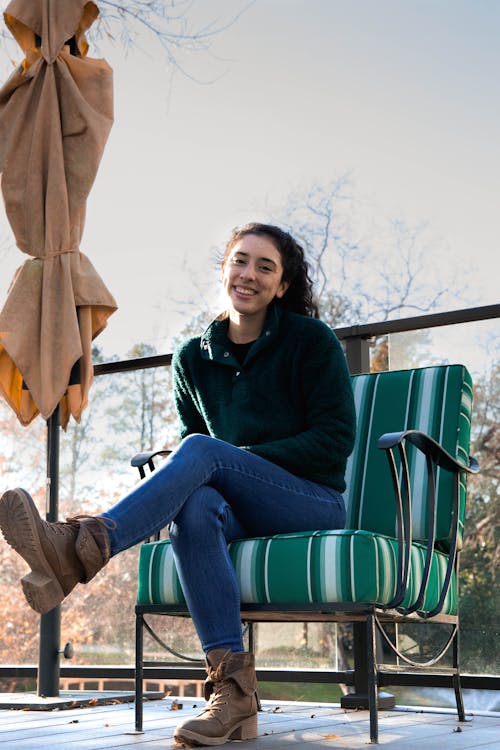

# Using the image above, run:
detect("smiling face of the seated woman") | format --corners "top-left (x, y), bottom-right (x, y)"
top-left (222, 234), bottom-right (289, 317)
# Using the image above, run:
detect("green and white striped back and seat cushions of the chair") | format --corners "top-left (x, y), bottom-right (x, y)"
top-left (137, 365), bottom-right (472, 614)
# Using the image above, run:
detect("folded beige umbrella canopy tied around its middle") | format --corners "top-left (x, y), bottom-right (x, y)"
top-left (0, 0), bottom-right (116, 427)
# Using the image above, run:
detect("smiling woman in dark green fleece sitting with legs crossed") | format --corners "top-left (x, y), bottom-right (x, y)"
top-left (0, 224), bottom-right (355, 745)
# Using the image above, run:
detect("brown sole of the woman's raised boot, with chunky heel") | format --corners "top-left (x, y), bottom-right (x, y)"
top-left (0, 489), bottom-right (64, 614)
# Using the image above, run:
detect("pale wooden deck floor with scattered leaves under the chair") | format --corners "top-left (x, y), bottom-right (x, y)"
top-left (0, 698), bottom-right (500, 750)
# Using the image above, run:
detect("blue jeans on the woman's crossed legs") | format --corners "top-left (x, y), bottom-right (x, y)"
top-left (103, 435), bottom-right (345, 652)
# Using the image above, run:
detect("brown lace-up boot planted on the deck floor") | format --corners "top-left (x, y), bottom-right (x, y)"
top-left (174, 648), bottom-right (257, 746)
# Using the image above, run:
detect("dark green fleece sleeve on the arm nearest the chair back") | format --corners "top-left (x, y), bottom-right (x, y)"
top-left (246, 325), bottom-right (356, 491)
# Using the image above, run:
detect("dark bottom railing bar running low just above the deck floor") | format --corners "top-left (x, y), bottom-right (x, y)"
top-left (0, 665), bottom-right (500, 690)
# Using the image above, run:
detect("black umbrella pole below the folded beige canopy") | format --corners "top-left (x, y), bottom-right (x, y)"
top-left (37, 406), bottom-right (61, 698)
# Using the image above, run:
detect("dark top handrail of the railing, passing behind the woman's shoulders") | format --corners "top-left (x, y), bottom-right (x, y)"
top-left (94, 305), bottom-right (500, 376)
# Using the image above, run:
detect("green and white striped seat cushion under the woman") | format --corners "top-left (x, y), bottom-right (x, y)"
top-left (137, 530), bottom-right (456, 614)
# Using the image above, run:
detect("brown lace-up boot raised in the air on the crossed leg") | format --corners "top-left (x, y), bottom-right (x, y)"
top-left (0, 488), bottom-right (113, 614)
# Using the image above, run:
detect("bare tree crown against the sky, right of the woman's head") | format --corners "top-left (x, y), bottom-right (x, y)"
top-left (277, 181), bottom-right (458, 324)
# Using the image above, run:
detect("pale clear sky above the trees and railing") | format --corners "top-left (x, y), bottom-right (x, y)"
top-left (0, 0), bottom-right (500, 364)
